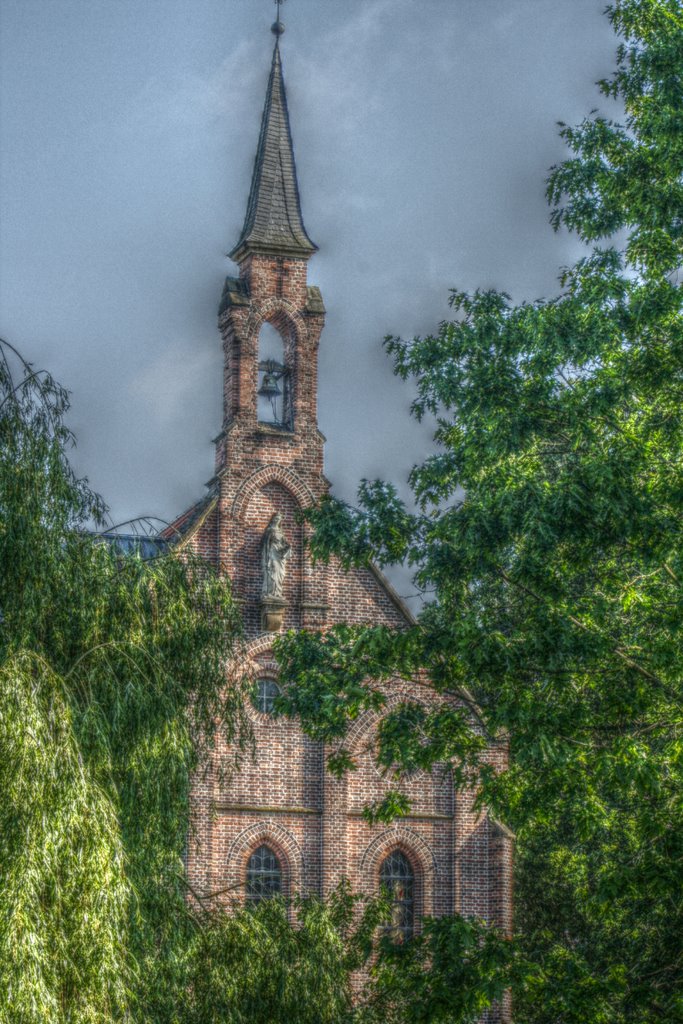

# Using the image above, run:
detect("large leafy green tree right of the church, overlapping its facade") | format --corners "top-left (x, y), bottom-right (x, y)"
top-left (279, 0), bottom-right (683, 1024)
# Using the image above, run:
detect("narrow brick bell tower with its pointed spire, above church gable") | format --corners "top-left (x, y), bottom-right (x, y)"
top-left (216, 22), bottom-right (327, 636)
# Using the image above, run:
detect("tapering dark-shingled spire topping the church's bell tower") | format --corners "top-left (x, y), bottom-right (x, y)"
top-left (229, 25), bottom-right (317, 262)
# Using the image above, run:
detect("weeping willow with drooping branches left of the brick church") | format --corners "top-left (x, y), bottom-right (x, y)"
top-left (0, 343), bottom-right (248, 1024)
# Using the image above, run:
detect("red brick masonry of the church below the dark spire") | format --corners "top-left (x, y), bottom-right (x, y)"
top-left (172, 252), bottom-right (512, 1022)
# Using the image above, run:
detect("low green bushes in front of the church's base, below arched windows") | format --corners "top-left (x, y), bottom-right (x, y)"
top-left (187, 883), bottom-right (520, 1024)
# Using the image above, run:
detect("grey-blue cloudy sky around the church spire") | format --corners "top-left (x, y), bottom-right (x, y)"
top-left (0, 0), bottom-right (616, 593)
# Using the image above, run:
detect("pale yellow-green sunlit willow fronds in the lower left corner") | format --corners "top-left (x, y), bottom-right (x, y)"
top-left (0, 654), bottom-right (131, 1022)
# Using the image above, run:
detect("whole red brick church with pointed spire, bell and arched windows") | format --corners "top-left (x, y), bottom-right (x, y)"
top-left (172, 20), bottom-right (511, 999)
